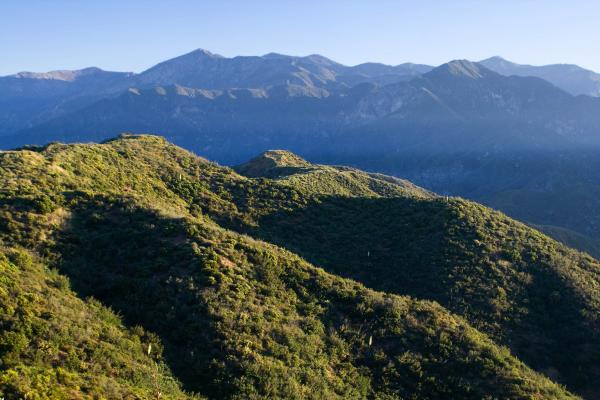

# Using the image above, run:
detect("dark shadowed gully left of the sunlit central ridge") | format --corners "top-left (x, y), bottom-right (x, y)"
top-left (56, 196), bottom-right (233, 397)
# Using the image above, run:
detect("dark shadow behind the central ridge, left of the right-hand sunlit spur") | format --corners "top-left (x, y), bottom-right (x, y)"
top-left (252, 197), bottom-right (448, 302)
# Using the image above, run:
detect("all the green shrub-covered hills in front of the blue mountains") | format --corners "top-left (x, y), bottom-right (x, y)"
top-left (0, 136), bottom-right (598, 399)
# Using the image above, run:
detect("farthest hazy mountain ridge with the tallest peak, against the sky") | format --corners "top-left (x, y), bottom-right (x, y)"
top-left (0, 49), bottom-right (431, 135)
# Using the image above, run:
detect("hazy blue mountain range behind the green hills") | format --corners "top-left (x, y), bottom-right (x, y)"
top-left (0, 50), bottom-right (600, 255)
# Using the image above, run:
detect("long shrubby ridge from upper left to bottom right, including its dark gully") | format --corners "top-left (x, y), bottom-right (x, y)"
top-left (0, 137), bottom-right (572, 399)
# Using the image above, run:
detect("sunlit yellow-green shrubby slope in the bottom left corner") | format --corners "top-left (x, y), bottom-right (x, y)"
top-left (0, 247), bottom-right (191, 399)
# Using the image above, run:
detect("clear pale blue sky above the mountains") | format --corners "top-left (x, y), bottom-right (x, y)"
top-left (0, 0), bottom-right (600, 75)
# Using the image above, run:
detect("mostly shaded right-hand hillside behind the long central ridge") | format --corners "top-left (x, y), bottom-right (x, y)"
top-left (248, 197), bottom-right (600, 393)
